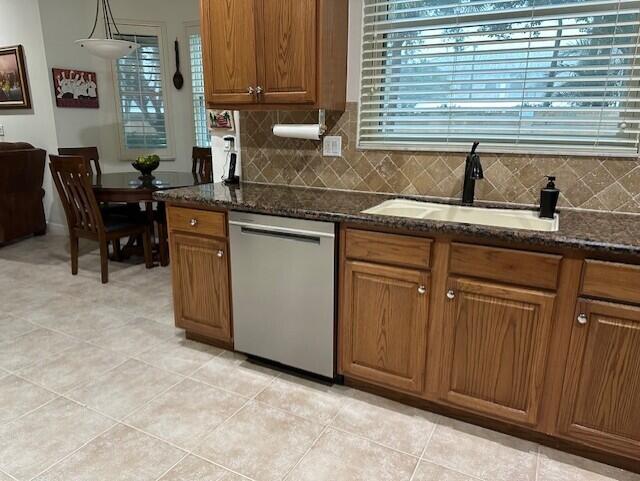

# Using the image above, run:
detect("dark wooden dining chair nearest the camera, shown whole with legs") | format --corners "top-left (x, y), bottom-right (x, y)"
top-left (49, 155), bottom-right (153, 284)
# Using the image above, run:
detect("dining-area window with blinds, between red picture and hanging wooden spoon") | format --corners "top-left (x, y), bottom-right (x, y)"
top-left (115, 27), bottom-right (169, 157)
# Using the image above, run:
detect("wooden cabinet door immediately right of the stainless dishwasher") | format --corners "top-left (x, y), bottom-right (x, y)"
top-left (342, 261), bottom-right (429, 392)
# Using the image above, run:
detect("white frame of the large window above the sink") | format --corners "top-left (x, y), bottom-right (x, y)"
top-left (356, 0), bottom-right (640, 160)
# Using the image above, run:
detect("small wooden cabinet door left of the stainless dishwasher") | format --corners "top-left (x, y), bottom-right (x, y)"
top-left (171, 232), bottom-right (231, 342)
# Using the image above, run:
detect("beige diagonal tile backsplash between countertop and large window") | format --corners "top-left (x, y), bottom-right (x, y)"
top-left (240, 103), bottom-right (640, 213)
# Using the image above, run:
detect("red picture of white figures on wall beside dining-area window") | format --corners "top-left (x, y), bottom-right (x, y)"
top-left (52, 68), bottom-right (100, 109)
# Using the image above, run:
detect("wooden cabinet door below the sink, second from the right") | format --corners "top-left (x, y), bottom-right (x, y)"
top-left (440, 278), bottom-right (555, 425)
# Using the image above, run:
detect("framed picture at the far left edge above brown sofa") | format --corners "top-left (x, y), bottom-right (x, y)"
top-left (0, 45), bottom-right (31, 109)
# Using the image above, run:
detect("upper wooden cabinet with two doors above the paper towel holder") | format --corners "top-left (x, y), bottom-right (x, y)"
top-left (201, 0), bottom-right (348, 110)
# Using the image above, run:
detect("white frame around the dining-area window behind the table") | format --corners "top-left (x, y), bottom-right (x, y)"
top-left (111, 19), bottom-right (176, 161)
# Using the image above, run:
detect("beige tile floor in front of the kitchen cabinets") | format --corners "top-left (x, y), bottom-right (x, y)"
top-left (0, 236), bottom-right (640, 481)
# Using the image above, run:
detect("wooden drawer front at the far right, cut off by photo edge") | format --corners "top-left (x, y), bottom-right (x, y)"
top-left (582, 259), bottom-right (640, 304)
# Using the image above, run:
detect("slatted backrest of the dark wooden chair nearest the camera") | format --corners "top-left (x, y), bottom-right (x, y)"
top-left (49, 155), bottom-right (104, 235)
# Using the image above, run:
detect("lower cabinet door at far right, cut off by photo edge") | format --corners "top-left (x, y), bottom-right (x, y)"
top-left (559, 300), bottom-right (640, 458)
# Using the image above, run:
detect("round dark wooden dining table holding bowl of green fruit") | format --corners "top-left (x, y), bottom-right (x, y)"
top-left (92, 170), bottom-right (212, 266)
